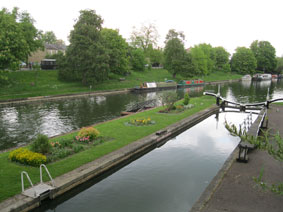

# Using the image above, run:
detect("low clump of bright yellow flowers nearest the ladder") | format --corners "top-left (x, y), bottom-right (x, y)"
top-left (9, 148), bottom-right (46, 166)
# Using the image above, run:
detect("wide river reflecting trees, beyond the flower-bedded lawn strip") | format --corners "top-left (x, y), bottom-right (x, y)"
top-left (0, 81), bottom-right (283, 150)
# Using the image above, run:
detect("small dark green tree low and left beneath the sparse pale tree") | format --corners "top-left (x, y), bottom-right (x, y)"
top-left (130, 48), bottom-right (146, 71)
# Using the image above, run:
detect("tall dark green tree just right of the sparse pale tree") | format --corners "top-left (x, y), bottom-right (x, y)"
top-left (164, 29), bottom-right (187, 78)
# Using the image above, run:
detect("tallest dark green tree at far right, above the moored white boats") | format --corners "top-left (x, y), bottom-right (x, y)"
top-left (250, 40), bottom-right (276, 73)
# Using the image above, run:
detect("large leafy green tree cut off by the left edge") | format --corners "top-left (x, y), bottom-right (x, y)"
top-left (0, 8), bottom-right (43, 70)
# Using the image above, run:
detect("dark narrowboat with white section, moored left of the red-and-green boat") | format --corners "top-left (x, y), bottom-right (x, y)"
top-left (132, 80), bottom-right (177, 92)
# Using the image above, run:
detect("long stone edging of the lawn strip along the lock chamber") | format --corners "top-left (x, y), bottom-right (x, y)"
top-left (0, 106), bottom-right (219, 212)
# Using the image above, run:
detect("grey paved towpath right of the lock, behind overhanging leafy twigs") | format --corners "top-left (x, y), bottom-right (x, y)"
top-left (191, 105), bottom-right (283, 212)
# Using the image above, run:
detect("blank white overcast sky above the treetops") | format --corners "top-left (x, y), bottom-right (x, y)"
top-left (0, 0), bottom-right (283, 56)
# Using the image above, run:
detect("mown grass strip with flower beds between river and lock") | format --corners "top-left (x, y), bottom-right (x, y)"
top-left (0, 96), bottom-right (215, 202)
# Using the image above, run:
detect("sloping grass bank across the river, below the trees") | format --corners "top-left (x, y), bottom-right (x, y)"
top-left (0, 69), bottom-right (241, 100)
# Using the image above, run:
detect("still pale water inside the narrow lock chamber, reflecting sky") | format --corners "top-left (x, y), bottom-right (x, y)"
top-left (33, 113), bottom-right (256, 212)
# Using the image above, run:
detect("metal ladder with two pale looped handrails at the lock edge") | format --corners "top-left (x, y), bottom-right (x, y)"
top-left (21, 164), bottom-right (55, 199)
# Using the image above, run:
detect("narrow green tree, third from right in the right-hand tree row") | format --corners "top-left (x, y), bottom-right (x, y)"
top-left (214, 46), bottom-right (230, 72)
